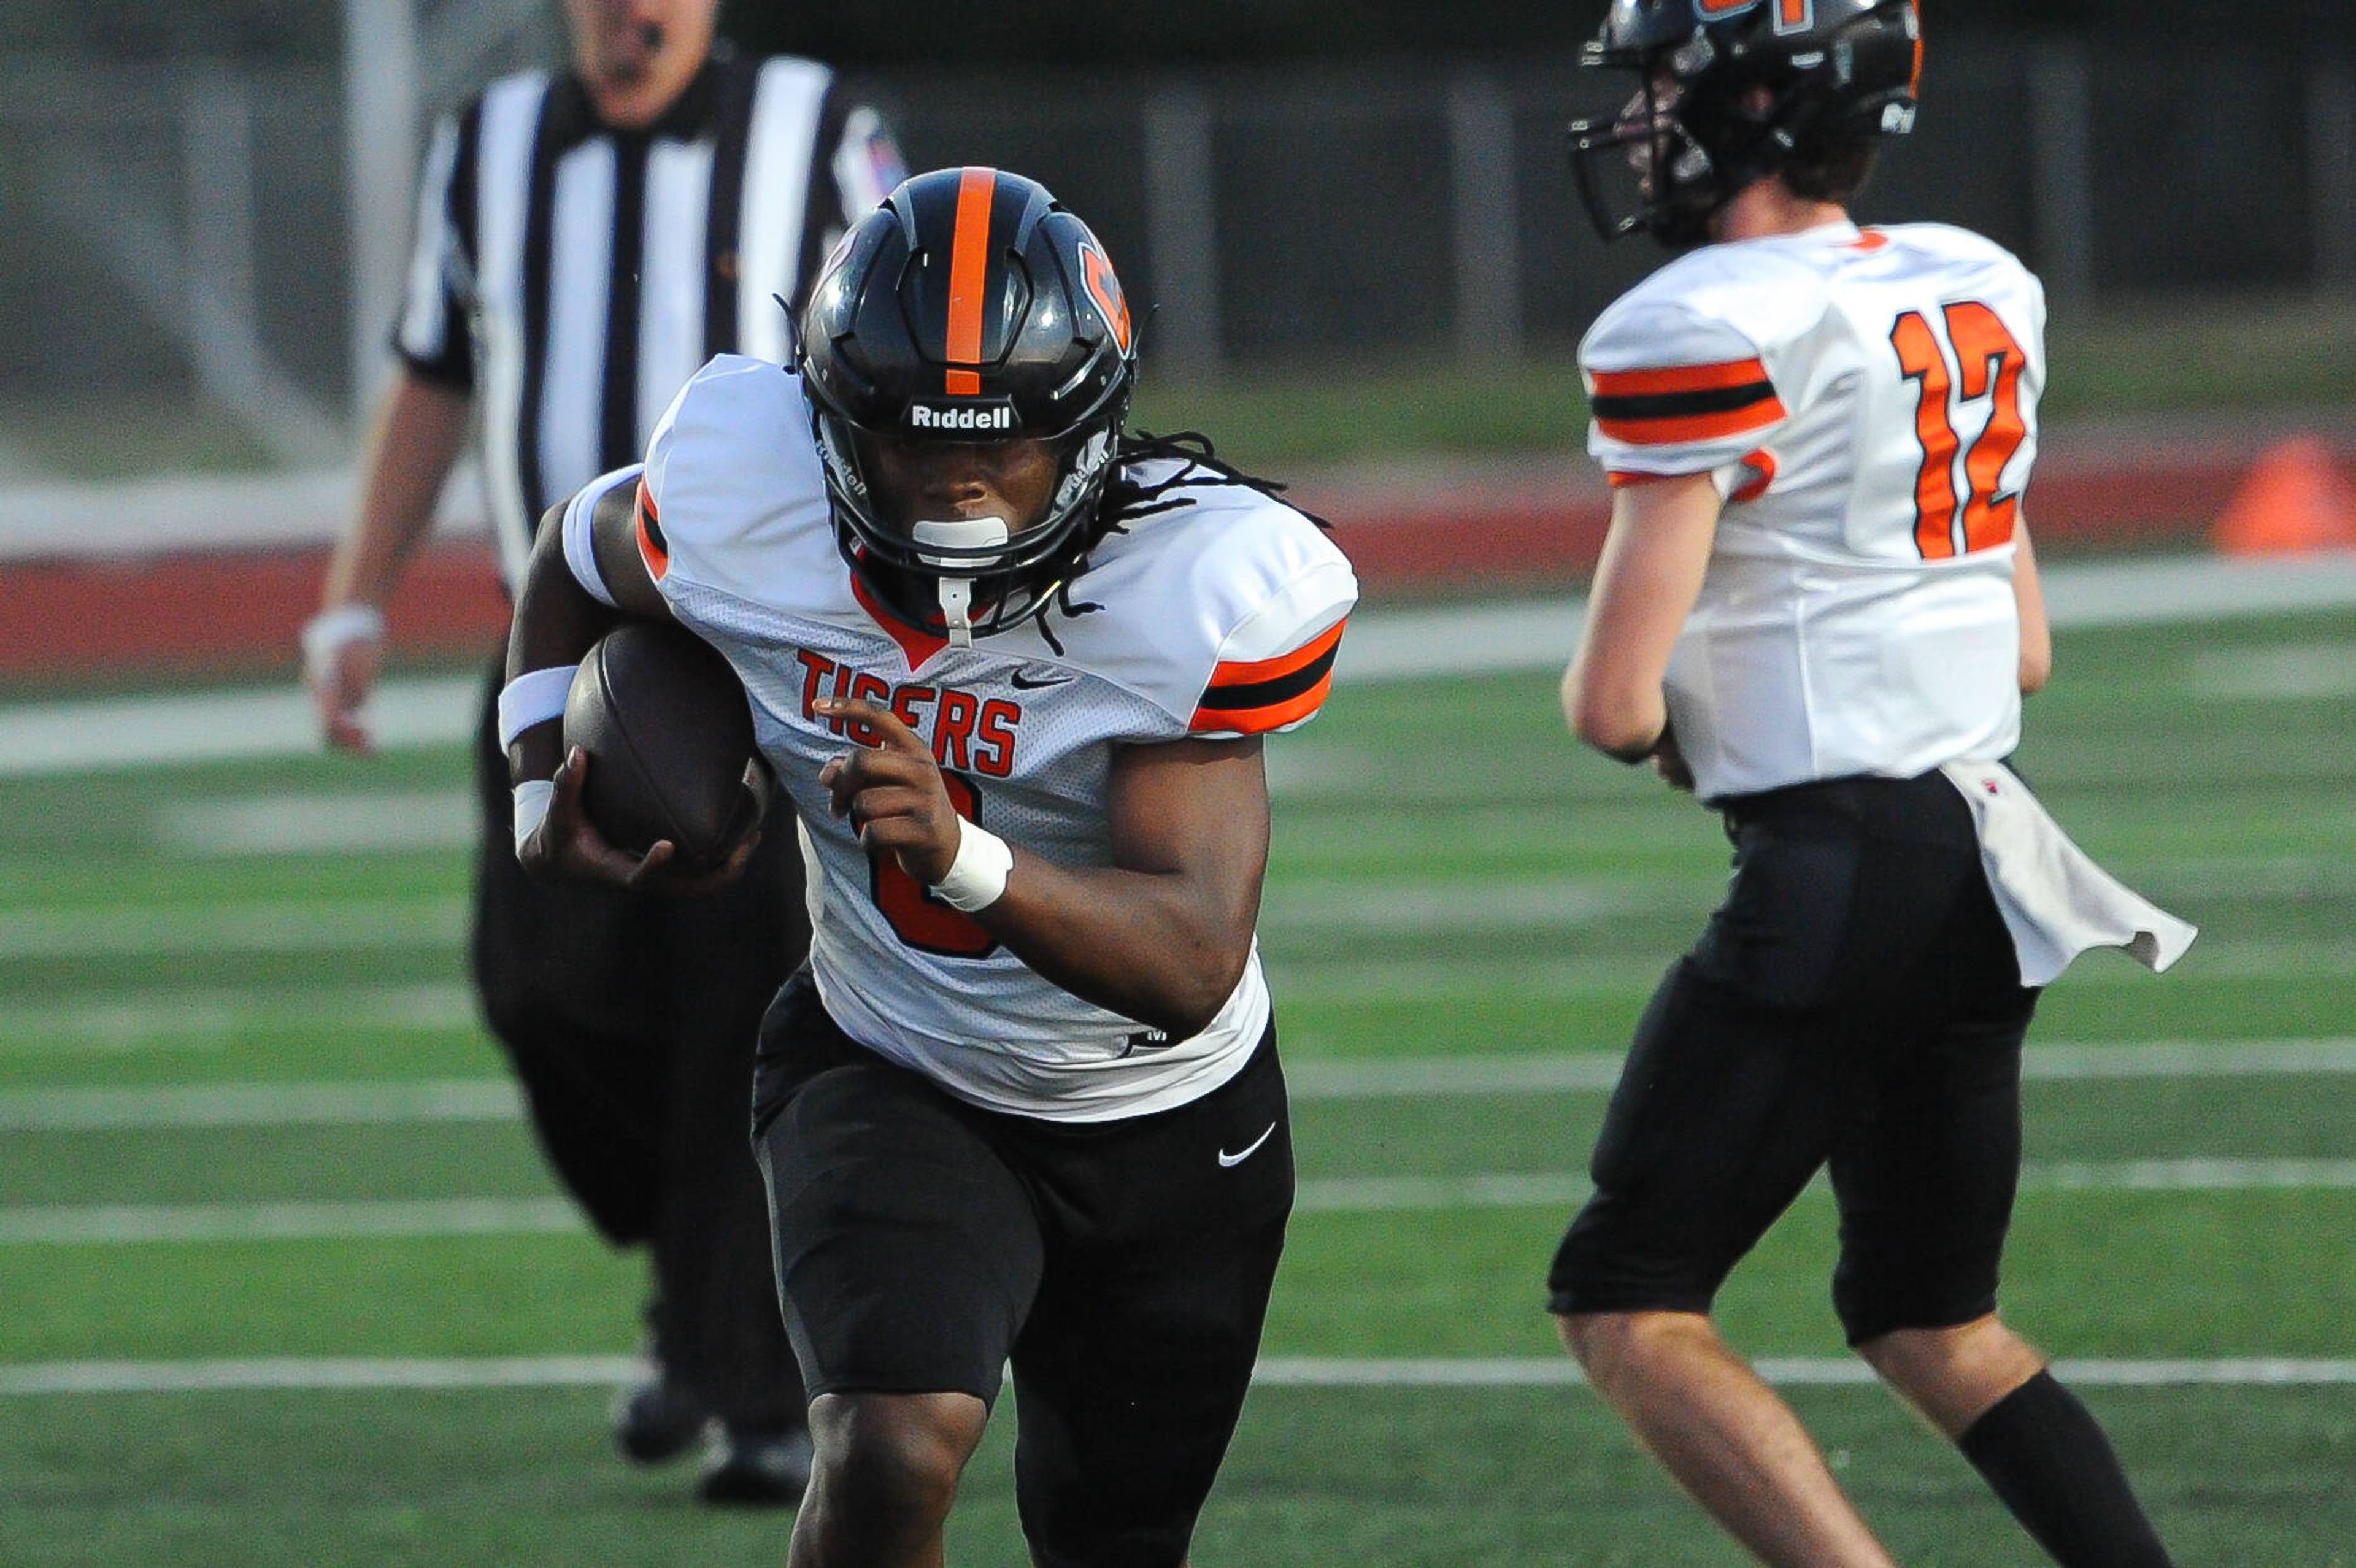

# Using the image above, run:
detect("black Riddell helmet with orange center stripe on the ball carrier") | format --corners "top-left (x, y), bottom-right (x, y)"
top-left (796, 167), bottom-right (1138, 645)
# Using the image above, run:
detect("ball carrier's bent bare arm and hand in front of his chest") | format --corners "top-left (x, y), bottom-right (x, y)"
top-left (817, 699), bottom-right (1268, 1038)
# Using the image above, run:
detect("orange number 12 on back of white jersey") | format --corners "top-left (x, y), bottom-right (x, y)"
top-left (1890, 299), bottom-right (2028, 560)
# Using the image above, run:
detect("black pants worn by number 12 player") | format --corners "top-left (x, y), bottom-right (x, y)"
top-left (1548, 772), bottom-right (2038, 1344)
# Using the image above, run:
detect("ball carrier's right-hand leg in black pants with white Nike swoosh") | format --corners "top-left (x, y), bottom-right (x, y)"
top-left (994, 1034), bottom-right (1293, 1568)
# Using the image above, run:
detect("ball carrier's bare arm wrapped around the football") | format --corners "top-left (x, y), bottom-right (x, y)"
top-left (507, 485), bottom-right (756, 893)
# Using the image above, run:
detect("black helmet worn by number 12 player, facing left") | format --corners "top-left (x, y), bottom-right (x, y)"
top-left (1571, 0), bottom-right (1922, 250)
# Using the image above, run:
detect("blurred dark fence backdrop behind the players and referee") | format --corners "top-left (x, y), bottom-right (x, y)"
top-left (0, 0), bottom-right (2356, 480)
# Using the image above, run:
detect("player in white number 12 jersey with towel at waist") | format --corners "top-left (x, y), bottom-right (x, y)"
top-left (1548, 0), bottom-right (2191, 1568)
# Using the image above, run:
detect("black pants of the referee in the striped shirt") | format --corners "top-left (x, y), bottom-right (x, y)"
top-left (471, 659), bottom-right (810, 1431)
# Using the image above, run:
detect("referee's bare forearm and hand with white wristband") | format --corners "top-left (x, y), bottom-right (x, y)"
top-left (302, 370), bottom-right (471, 751)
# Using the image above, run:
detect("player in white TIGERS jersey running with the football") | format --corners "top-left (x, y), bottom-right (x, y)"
top-left (507, 169), bottom-right (1357, 1568)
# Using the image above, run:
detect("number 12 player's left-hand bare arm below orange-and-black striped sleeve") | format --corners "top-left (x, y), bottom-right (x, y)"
top-left (1562, 473), bottom-right (1720, 763)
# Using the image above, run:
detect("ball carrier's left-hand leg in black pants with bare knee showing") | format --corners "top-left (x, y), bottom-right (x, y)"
top-left (754, 972), bottom-right (1044, 1568)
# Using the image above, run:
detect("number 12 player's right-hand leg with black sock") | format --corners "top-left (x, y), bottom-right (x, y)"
top-left (1833, 843), bottom-right (2170, 1568)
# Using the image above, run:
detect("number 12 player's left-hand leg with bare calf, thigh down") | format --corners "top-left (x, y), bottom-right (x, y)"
top-left (1548, 963), bottom-right (1890, 1568)
